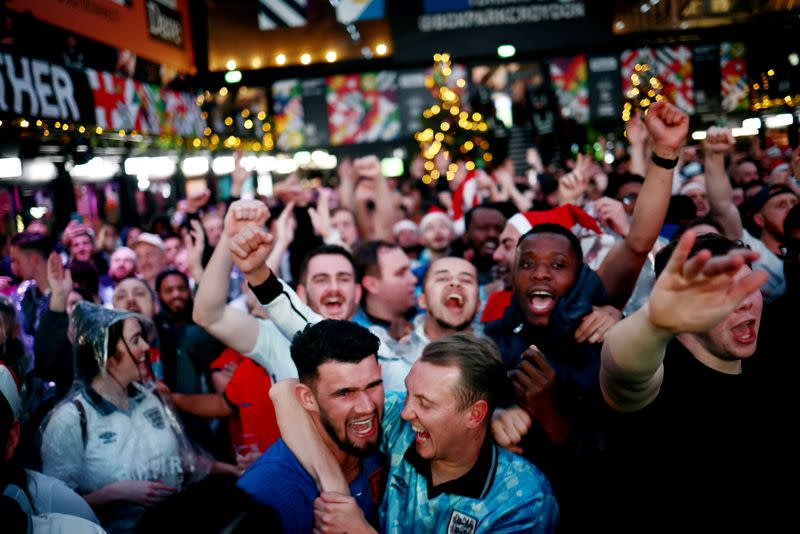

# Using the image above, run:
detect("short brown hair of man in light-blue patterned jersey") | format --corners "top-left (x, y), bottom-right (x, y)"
top-left (420, 333), bottom-right (506, 424)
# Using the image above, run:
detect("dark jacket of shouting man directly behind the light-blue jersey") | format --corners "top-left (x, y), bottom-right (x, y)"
top-left (484, 265), bottom-right (608, 532)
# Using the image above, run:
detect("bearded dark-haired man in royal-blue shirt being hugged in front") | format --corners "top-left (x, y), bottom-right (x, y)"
top-left (237, 319), bottom-right (386, 532)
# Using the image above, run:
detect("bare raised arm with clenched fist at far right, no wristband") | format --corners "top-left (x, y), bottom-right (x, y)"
top-left (703, 127), bottom-right (744, 239)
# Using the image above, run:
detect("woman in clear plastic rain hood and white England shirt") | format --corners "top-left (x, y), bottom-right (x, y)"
top-left (42, 302), bottom-right (213, 532)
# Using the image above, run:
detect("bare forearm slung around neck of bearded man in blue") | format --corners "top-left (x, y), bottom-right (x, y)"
top-left (269, 379), bottom-right (350, 495)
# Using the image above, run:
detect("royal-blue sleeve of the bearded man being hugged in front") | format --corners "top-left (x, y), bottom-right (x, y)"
top-left (236, 462), bottom-right (318, 532)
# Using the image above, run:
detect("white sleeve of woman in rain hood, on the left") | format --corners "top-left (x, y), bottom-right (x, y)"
top-left (42, 400), bottom-right (84, 489)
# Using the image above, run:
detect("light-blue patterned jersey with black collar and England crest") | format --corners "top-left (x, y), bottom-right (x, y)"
top-left (380, 393), bottom-right (558, 534)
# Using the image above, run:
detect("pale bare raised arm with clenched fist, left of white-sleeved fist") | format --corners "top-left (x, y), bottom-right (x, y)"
top-left (192, 200), bottom-right (269, 353)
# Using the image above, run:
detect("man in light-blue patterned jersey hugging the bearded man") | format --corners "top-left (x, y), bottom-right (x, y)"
top-left (271, 334), bottom-right (558, 533)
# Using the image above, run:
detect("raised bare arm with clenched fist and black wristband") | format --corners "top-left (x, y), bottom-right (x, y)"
top-left (597, 101), bottom-right (689, 308)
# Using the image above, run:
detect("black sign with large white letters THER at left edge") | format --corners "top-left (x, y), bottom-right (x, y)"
top-left (0, 53), bottom-right (93, 122)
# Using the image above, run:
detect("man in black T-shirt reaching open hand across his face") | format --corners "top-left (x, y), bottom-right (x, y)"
top-left (600, 230), bottom-right (780, 532)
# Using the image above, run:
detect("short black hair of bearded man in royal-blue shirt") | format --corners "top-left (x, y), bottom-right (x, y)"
top-left (290, 319), bottom-right (380, 384)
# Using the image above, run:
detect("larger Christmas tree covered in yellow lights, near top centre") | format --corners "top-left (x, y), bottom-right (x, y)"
top-left (414, 54), bottom-right (492, 184)
